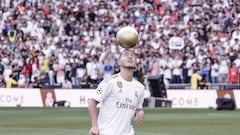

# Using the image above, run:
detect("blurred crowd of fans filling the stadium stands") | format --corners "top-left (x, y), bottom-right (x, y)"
top-left (0, 0), bottom-right (240, 88)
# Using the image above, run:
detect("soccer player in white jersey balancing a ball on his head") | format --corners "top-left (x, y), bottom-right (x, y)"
top-left (88, 49), bottom-right (144, 135)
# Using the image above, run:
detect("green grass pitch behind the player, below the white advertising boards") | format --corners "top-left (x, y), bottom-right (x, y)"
top-left (0, 108), bottom-right (240, 135)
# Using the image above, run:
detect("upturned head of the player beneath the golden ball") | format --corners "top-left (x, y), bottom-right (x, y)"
top-left (118, 49), bottom-right (136, 69)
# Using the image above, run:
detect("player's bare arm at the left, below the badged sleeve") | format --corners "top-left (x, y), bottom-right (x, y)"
top-left (88, 99), bottom-right (99, 135)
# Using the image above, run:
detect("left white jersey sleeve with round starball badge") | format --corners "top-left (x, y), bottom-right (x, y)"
top-left (93, 81), bottom-right (111, 102)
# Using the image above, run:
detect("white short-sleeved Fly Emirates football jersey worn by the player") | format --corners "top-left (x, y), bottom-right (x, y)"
top-left (94, 74), bottom-right (145, 135)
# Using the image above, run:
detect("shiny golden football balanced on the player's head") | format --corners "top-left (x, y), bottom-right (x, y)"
top-left (116, 26), bottom-right (138, 48)
